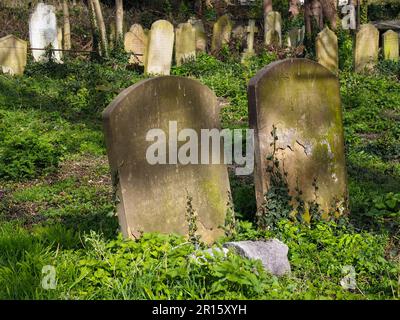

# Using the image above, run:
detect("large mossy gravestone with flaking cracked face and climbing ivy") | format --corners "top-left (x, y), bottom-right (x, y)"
top-left (249, 59), bottom-right (347, 215)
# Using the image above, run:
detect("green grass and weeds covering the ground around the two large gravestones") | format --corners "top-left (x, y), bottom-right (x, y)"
top-left (0, 53), bottom-right (400, 299)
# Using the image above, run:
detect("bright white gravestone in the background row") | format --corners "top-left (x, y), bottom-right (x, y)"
top-left (29, 2), bottom-right (61, 62)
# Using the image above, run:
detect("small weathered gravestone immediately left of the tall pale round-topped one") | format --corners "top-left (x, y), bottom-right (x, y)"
top-left (124, 24), bottom-right (148, 65)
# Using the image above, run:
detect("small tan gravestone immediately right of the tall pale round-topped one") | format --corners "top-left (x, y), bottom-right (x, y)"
top-left (175, 23), bottom-right (196, 66)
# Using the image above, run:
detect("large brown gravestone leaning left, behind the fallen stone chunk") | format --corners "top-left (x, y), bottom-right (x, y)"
top-left (103, 76), bottom-right (229, 243)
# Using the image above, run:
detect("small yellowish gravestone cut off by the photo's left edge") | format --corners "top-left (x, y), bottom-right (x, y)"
top-left (0, 35), bottom-right (28, 75)
